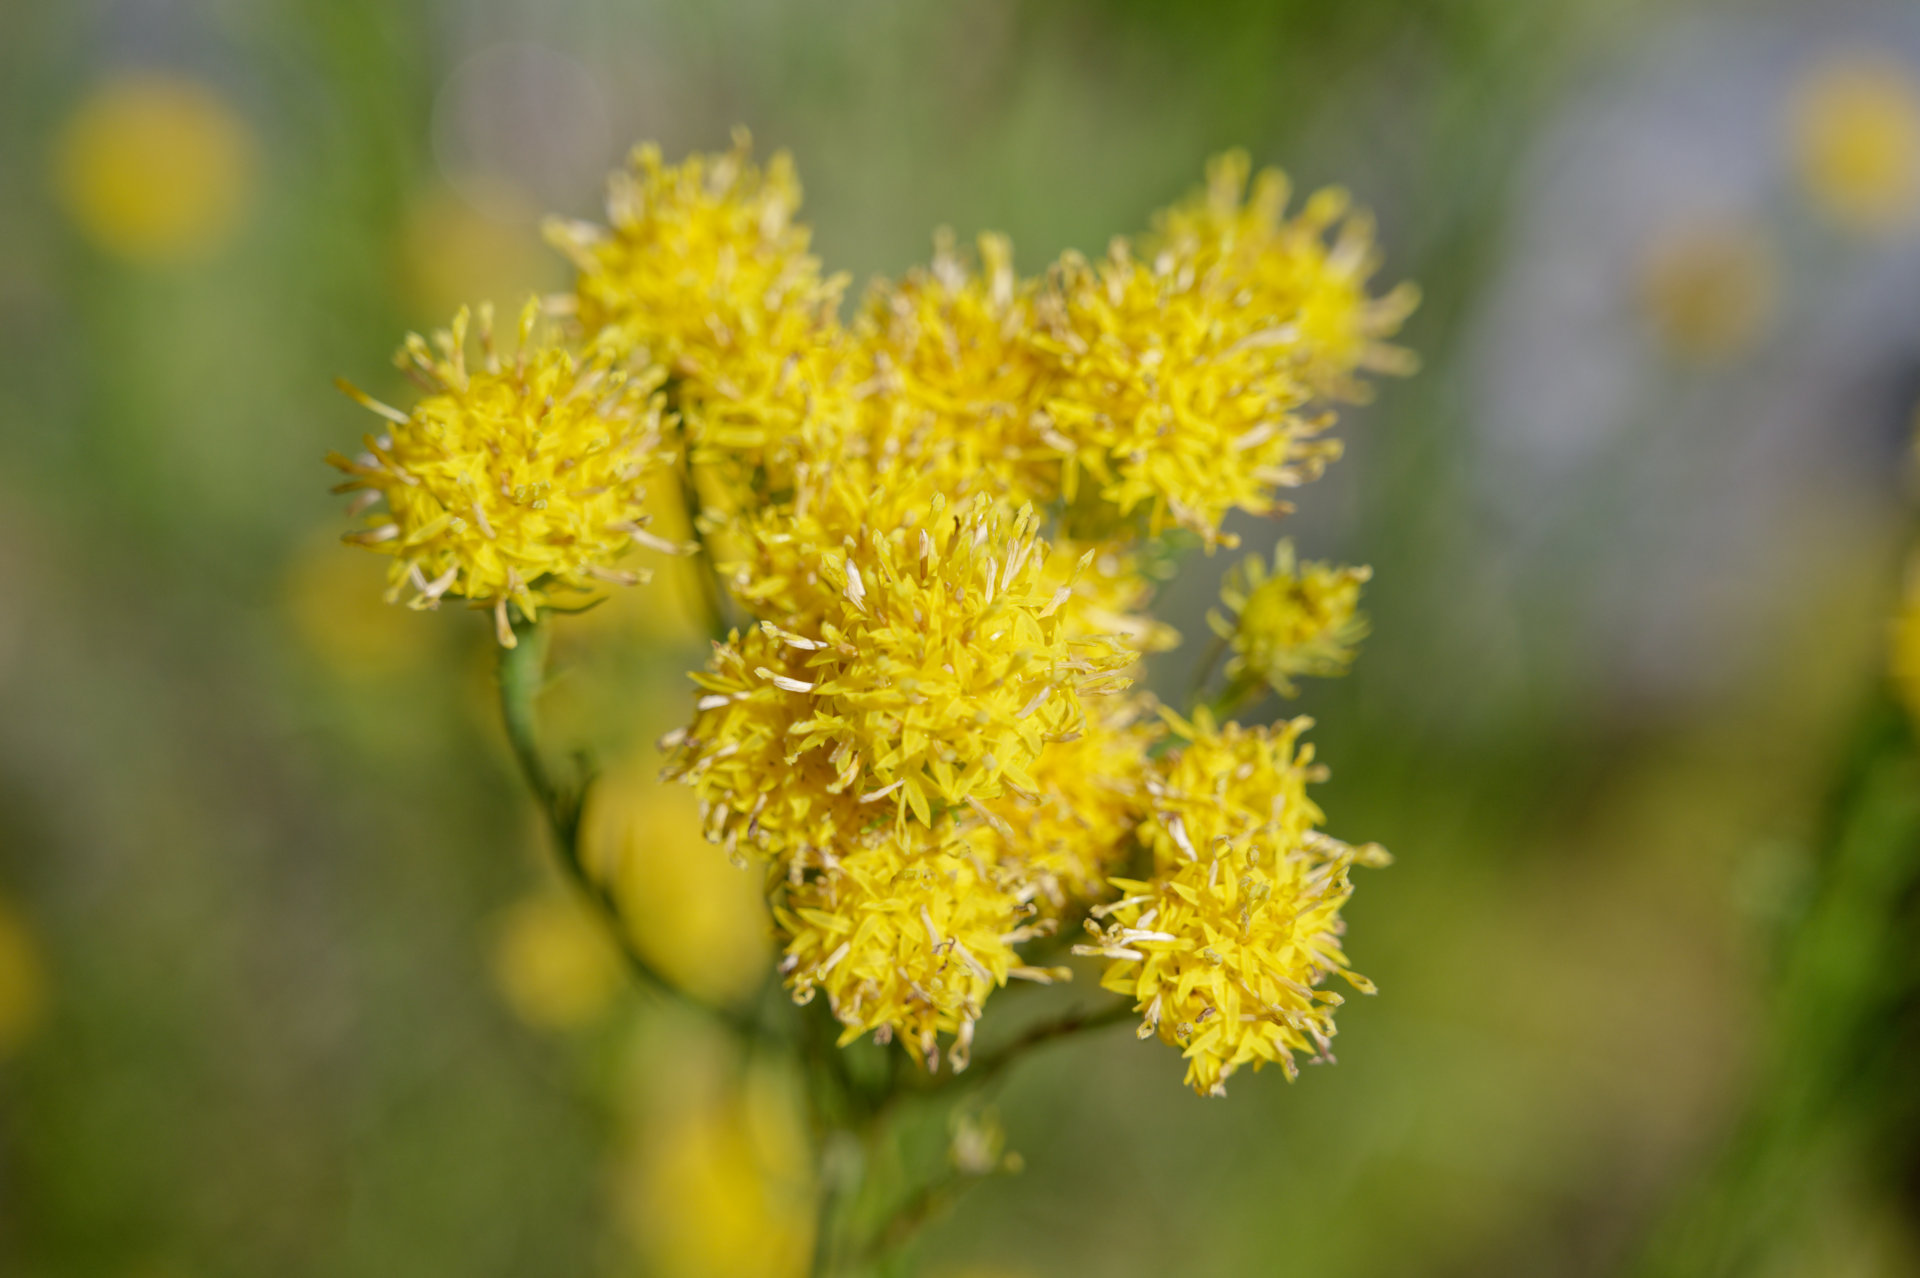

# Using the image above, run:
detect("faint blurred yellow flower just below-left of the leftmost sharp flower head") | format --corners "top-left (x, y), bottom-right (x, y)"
top-left (282, 537), bottom-right (434, 675)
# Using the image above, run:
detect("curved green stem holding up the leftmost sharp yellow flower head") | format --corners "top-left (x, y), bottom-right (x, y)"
top-left (499, 620), bottom-right (758, 1040)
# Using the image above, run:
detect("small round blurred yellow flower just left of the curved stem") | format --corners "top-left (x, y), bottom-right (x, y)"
top-left (493, 890), bottom-right (626, 1029)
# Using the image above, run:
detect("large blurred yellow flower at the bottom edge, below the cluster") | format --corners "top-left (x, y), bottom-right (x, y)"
top-left (618, 1069), bottom-right (814, 1278)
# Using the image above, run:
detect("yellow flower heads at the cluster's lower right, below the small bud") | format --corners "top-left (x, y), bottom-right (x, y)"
top-left (1075, 712), bottom-right (1386, 1096)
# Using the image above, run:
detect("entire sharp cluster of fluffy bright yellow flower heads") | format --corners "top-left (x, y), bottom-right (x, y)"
top-left (326, 136), bottom-right (1413, 1092)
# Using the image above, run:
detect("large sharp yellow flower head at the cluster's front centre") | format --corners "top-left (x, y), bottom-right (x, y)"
top-left (674, 501), bottom-right (1135, 854)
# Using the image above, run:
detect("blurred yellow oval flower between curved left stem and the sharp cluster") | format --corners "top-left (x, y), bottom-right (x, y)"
top-left (580, 750), bottom-right (774, 1002)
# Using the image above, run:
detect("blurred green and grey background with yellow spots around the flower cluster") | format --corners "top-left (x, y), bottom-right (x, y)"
top-left (0, 0), bottom-right (1920, 1278)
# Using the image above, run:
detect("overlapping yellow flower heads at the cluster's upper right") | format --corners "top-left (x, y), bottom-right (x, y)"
top-left (1037, 154), bottom-right (1415, 547)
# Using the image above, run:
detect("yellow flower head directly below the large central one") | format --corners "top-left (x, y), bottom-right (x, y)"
top-left (774, 825), bottom-right (1033, 1069)
